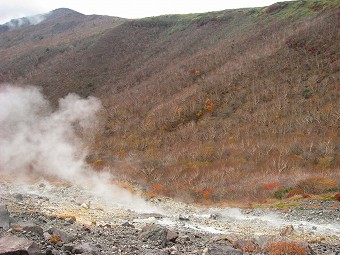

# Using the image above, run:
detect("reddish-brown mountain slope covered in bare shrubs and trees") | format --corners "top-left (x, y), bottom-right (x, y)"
top-left (0, 0), bottom-right (340, 201)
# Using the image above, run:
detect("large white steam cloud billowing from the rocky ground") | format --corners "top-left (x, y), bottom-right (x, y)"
top-left (0, 84), bottom-right (161, 211)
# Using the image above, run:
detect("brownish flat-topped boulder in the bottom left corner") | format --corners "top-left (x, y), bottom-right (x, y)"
top-left (0, 236), bottom-right (43, 255)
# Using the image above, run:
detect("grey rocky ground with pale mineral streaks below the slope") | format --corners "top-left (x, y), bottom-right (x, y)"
top-left (0, 178), bottom-right (340, 255)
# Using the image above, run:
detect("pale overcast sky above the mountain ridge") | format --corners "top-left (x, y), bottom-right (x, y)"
top-left (0, 0), bottom-right (294, 24)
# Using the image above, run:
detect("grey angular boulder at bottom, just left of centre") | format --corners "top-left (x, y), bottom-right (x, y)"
top-left (139, 224), bottom-right (168, 247)
